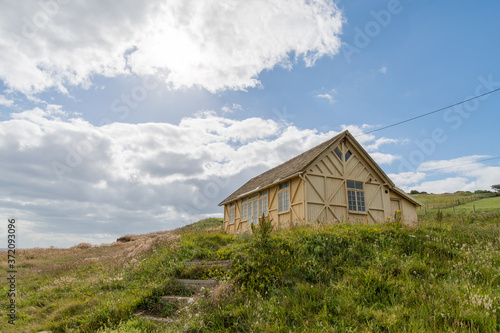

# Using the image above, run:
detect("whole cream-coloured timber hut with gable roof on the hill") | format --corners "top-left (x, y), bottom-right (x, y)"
top-left (219, 130), bottom-right (422, 233)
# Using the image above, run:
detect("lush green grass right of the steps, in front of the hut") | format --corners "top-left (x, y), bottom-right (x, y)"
top-left (186, 217), bottom-right (500, 332)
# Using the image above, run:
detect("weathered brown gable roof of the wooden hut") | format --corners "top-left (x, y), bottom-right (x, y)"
top-left (219, 130), bottom-right (422, 206)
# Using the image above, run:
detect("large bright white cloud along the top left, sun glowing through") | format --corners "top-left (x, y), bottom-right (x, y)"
top-left (0, 0), bottom-right (343, 94)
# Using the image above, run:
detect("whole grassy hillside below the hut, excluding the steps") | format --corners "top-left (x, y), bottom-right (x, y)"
top-left (0, 209), bottom-right (500, 333)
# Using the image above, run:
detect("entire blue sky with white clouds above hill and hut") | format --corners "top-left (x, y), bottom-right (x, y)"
top-left (0, 0), bottom-right (500, 247)
